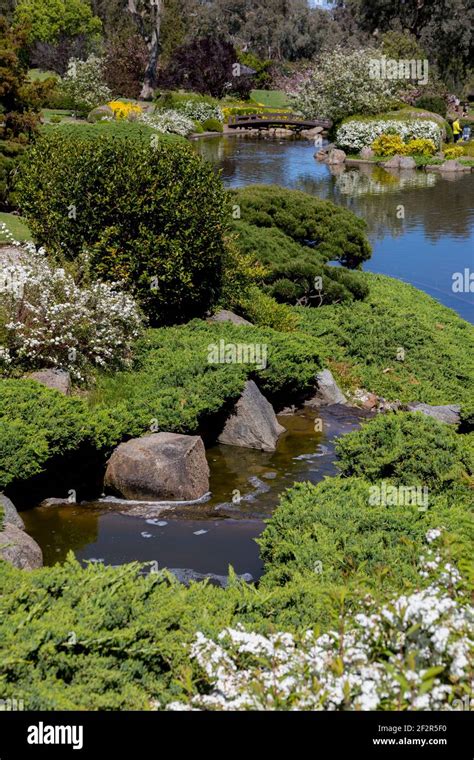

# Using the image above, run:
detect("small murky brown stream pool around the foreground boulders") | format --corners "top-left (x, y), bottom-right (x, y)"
top-left (22, 406), bottom-right (367, 578)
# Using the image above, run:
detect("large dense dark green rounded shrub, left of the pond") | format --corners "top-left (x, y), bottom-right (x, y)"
top-left (17, 133), bottom-right (228, 324)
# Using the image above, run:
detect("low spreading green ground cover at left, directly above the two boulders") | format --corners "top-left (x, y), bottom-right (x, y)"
top-left (0, 315), bottom-right (321, 490)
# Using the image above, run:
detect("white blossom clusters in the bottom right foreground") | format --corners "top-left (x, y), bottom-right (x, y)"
top-left (167, 530), bottom-right (474, 710)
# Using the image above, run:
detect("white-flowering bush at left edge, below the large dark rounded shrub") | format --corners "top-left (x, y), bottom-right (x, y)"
top-left (0, 235), bottom-right (142, 381)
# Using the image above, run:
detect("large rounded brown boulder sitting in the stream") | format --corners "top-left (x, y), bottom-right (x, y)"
top-left (104, 433), bottom-right (209, 501)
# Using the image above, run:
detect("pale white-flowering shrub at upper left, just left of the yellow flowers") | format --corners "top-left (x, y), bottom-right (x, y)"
top-left (61, 55), bottom-right (112, 113)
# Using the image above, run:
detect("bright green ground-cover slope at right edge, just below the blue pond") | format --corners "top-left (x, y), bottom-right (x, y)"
top-left (297, 273), bottom-right (474, 404)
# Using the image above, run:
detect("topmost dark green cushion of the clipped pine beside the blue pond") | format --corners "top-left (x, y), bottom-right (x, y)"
top-left (231, 185), bottom-right (371, 268)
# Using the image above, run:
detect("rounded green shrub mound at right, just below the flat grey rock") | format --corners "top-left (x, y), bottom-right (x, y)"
top-left (336, 413), bottom-right (465, 492)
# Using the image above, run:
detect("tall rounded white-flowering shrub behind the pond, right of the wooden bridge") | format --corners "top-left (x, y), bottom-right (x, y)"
top-left (294, 47), bottom-right (400, 121)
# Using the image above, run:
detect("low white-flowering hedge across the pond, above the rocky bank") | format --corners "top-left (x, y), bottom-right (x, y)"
top-left (336, 119), bottom-right (441, 151)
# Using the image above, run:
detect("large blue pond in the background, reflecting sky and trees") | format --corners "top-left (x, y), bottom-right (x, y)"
top-left (194, 137), bottom-right (474, 322)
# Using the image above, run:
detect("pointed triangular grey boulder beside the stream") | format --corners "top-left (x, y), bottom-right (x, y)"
top-left (218, 380), bottom-right (285, 451)
